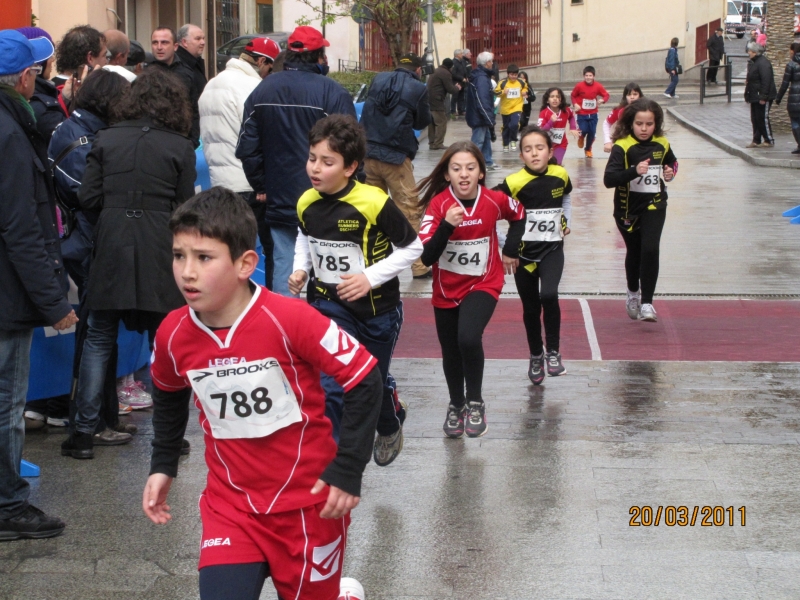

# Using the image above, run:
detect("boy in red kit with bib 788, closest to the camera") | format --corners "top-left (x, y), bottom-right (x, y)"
top-left (142, 187), bottom-right (381, 600)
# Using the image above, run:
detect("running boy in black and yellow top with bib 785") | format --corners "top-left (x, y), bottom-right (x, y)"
top-left (289, 115), bottom-right (422, 466)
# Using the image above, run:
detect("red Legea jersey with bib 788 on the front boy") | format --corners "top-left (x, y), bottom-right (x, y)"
top-left (151, 286), bottom-right (376, 514)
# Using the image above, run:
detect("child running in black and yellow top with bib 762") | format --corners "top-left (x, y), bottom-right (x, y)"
top-left (494, 125), bottom-right (572, 385)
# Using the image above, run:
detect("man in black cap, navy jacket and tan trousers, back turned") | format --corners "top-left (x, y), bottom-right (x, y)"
top-left (361, 52), bottom-right (431, 279)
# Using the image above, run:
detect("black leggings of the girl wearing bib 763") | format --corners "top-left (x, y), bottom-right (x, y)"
top-left (617, 209), bottom-right (667, 304)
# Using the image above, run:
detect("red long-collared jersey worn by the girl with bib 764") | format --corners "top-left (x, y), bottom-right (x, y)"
top-left (419, 185), bottom-right (525, 308)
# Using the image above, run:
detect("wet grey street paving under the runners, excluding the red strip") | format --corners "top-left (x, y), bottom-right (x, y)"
top-left (6, 99), bottom-right (800, 600)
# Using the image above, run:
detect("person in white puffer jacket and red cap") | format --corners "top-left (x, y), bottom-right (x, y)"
top-left (199, 37), bottom-right (281, 289)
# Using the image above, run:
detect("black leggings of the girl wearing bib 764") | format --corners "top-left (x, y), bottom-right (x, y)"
top-left (433, 292), bottom-right (497, 407)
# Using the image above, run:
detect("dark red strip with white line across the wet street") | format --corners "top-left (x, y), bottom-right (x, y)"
top-left (394, 298), bottom-right (800, 362)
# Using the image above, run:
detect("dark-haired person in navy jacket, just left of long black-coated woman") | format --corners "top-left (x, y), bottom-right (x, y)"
top-left (47, 70), bottom-right (134, 433)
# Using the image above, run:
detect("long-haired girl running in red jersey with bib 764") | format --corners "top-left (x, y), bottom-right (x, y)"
top-left (417, 142), bottom-right (525, 438)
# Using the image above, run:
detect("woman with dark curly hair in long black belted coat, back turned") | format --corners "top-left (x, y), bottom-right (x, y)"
top-left (61, 69), bottom-right (196, 458)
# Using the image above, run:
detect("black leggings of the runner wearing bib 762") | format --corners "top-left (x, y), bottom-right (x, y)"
top-left (514, 245), bottom-right (564, 356)
